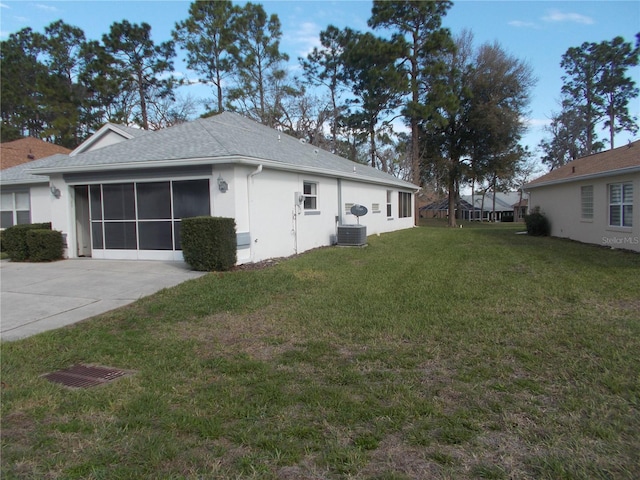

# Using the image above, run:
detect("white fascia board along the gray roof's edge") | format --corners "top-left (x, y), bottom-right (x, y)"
top-left (28, 156), bottom-right (419, 192)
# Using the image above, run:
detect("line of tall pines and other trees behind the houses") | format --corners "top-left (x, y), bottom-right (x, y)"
top-left (0, 0), bottom-right (638, 227)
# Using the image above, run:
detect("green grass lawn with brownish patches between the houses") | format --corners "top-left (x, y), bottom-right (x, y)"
top-left (1, 224), bottom-right (640, 480)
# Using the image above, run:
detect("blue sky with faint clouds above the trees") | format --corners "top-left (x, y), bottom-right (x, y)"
top-left (0, 0), bottom-right (640, 163)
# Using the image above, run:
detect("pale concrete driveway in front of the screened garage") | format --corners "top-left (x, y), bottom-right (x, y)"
top-left (0, 259), bottom-right (203, 340)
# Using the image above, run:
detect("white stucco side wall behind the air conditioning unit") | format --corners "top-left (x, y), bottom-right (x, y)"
top-left (228, 167), bottom-right (414, 263)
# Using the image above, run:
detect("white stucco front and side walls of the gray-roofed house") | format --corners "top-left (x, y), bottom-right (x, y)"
top-left (47, 164), bottom-right (414, 264)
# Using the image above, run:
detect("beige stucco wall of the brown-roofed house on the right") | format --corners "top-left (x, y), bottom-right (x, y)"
top-left (529, 174), bottom-right (640, 252)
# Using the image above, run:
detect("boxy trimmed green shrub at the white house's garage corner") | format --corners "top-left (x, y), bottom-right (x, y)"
top-left (180, 217), bottom-right (237, 272)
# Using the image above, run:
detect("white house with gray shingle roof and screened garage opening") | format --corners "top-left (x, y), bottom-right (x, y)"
top-left (0, 112), bottom-right (418, 263)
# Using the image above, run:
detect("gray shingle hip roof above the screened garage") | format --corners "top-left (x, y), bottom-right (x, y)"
top-left (27, 112), bottom-right (417, 189)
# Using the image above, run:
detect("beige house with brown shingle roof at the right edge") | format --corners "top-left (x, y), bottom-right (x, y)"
top-left (525, 141), bottom-right (640, 252)
